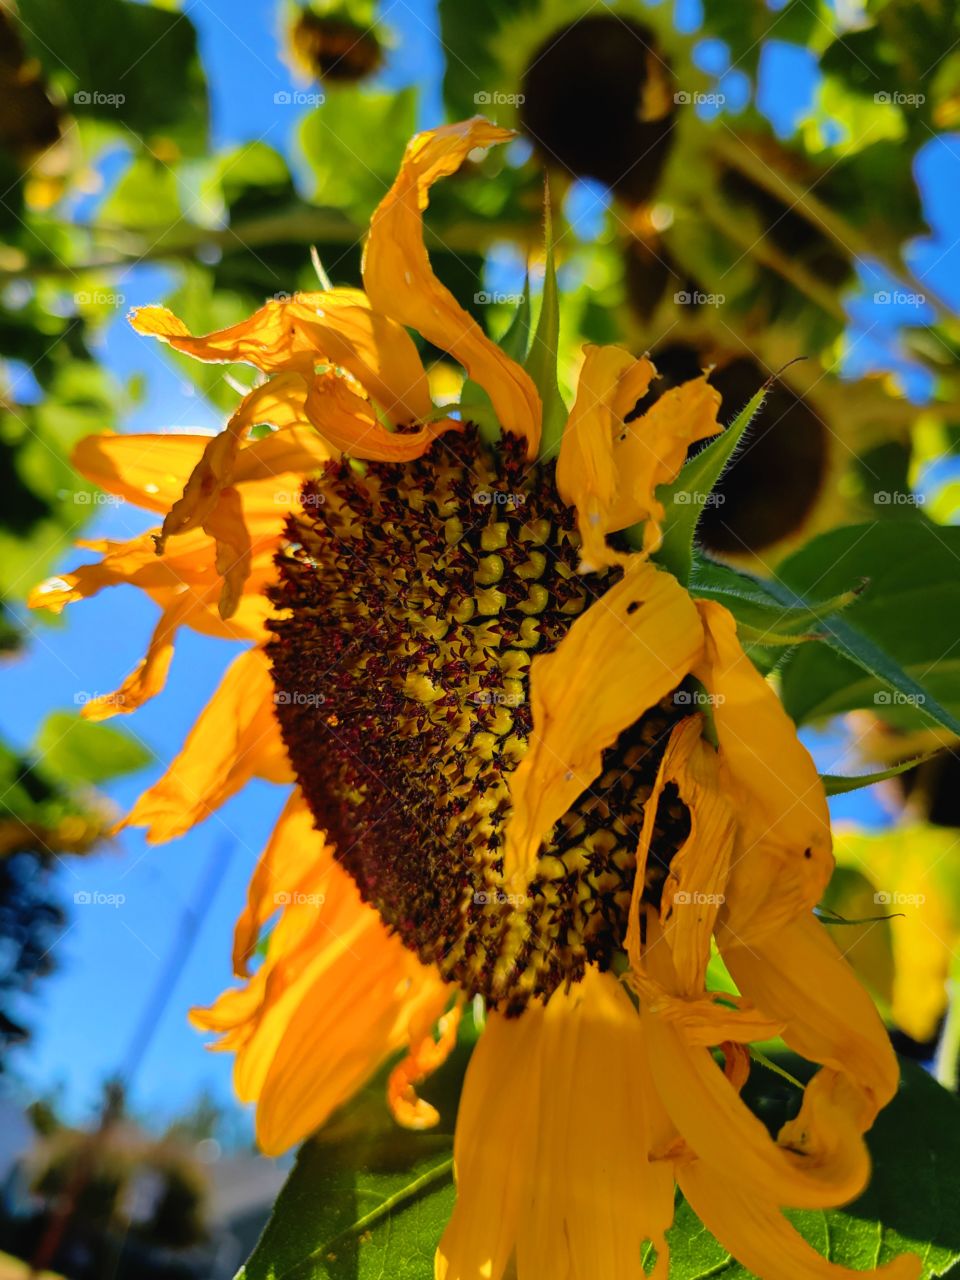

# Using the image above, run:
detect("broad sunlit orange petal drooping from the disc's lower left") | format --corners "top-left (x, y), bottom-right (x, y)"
top-left (198, 849), bottom-right (449, 1155)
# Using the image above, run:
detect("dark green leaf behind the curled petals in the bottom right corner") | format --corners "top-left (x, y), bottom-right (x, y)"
top-left (667, 1055), bottom-right (960, 1280)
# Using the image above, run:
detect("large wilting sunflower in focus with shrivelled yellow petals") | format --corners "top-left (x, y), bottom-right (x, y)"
top-left (36, 119), bottom-right (919, 1280)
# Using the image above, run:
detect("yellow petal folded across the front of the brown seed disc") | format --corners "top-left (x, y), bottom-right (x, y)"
top-left (504, 557), bottom-right (703, 883)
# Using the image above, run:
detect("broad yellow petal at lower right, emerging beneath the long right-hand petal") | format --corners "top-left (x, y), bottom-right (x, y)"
top-left (721, 915), bottom-right (899, 1111)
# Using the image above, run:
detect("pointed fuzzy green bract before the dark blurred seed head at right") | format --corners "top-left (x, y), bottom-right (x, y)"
top-left (650, 388), bottom-right (767, 586)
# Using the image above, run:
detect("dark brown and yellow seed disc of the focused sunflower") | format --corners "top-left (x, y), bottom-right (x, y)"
top-left (269, 429), bottom-right (689, 1011)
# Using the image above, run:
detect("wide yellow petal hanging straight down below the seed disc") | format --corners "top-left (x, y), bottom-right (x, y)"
top-left (436, 968), bottom-right (673, 1280)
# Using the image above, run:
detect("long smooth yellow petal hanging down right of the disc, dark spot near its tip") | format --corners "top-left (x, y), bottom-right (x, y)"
top-left (694, 600), bottom-right (833, 941)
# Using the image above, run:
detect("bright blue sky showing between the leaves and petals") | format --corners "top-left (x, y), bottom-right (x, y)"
top-left (0, 0), bottom-right (960, 1136)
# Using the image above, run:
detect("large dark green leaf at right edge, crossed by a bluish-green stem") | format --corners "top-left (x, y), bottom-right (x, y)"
top-left (783, 518), bottom-right (960, 733)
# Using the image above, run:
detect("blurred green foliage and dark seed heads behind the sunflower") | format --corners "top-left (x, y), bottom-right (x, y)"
top-left (0, 0), bottom-right (960, 1277)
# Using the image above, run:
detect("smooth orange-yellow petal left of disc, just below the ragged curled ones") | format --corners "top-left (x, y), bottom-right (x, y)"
top-left (125, 649), bottom-right (292, 844)
